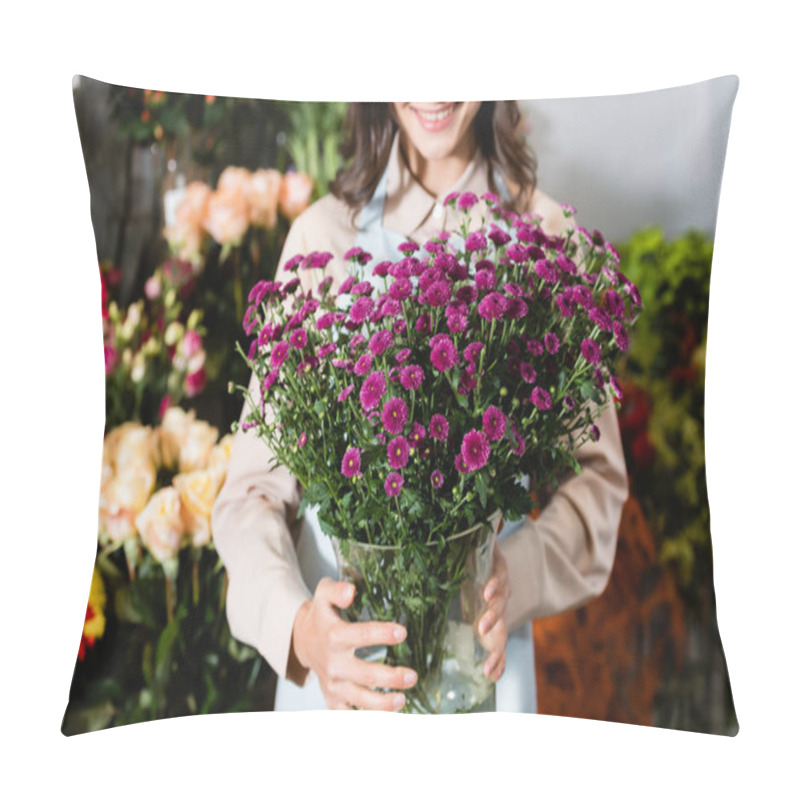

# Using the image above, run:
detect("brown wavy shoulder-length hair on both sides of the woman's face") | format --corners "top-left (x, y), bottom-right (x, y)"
top-left (329, 100), bottom-right (537, 222)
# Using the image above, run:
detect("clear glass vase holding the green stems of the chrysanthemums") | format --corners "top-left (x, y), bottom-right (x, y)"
top-left (334, 512), bottom-right (500, 714)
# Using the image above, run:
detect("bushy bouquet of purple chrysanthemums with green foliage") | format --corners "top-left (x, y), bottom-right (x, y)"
top-left (230, 193), bottom-right (640, 712)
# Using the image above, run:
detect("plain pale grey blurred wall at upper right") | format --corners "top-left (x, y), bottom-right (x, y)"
top-left (520, 76), bottom-right (739, 241)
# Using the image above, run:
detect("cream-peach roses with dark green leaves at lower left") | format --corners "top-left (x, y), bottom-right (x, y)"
top-left (64, 406), bottom-right (268, 733)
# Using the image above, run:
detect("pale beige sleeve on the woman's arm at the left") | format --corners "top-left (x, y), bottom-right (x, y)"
top-left (211, 216), bottom-right (311, 683)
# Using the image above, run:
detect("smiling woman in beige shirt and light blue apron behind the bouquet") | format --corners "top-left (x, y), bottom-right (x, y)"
top-left (212, 102), bottom-right (627, 712)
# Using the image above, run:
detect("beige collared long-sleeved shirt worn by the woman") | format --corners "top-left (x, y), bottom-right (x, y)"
top-left (211, 137), bottom-right (628, 684)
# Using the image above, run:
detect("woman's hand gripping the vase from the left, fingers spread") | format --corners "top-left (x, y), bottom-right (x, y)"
top-left (292, 578), bottom-right (417, 711)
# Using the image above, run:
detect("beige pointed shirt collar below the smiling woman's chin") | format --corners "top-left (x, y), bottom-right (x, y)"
top-left (383, 131), bottom-right (489, 241)
